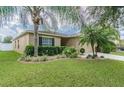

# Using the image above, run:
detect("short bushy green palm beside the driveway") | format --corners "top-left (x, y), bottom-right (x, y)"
top-left (80, 25), bottom-right (119, 57)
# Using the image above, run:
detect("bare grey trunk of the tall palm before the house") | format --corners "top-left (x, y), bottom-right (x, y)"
top-left (34, 24), bottom-right (39, 57)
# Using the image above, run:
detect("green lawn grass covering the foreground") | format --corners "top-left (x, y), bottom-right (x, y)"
top-left (0, 52), bottom-right (124, 87)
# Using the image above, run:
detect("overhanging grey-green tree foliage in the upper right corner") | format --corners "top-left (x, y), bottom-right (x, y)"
top-left (87, 6), bottom-right (124, 27)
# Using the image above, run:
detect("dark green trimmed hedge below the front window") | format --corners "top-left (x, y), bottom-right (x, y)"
top-left (25, 45), bottom-right (65, 56)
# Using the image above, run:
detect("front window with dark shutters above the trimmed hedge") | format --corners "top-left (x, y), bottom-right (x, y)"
top-left (39, 37), bottom-right (54, 46)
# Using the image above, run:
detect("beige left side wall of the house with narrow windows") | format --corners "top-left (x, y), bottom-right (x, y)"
top-left (12, 34), bottom-right (29, 53)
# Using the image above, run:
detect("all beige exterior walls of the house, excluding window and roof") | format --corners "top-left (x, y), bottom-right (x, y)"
top-left (12, 33), bottom-right (92, 53)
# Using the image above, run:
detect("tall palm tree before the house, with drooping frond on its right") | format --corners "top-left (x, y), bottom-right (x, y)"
top-left (24, 6), bottom-right (57, 56)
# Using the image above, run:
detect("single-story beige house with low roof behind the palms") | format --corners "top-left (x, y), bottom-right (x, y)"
top-left (12, 30), bottom-right (91, 53)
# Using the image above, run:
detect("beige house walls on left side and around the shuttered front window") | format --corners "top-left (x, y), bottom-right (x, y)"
top-left (12, 33), bottom-right (61, 53)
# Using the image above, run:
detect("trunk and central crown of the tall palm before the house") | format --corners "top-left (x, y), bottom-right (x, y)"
top-left (25, 6), bottom-right (44, 56)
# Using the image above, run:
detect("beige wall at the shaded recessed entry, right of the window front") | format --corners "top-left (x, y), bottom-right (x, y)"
top-left (66, 37), bottom-right (92, 52)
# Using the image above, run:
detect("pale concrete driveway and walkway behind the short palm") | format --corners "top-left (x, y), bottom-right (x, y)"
top-left (82, 53), bottom-right (124, 61)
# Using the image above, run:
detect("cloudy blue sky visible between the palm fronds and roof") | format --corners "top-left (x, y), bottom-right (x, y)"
top-left (0, 7), bottom-right (124, 41)
